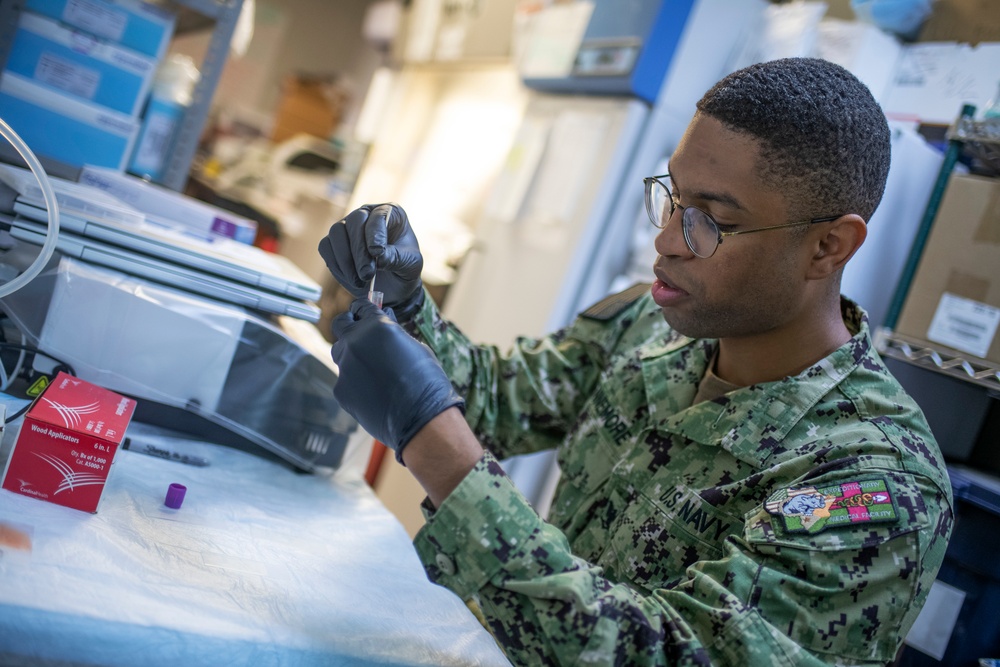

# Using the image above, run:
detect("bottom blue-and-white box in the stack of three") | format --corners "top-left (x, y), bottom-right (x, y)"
top-left (0, 71), bottom-right (139, 171)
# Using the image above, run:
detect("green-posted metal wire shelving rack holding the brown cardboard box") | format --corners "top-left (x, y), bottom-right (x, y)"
top-left (875, 111), bottom-right (1000, 398)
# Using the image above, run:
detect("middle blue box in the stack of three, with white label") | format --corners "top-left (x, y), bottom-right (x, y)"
top-left (7, 12), bottom-right (156, 116)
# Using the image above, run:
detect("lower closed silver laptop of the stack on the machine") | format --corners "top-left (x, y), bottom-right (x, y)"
top-left (9, 216), bottom-right (320, 322)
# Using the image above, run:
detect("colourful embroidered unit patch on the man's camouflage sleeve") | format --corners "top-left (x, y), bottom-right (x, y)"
top-left (764, 479), bottom-right (899, 533)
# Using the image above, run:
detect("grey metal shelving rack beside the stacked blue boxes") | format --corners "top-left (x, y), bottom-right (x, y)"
top-left (0, 0), bottom-right (243, 191)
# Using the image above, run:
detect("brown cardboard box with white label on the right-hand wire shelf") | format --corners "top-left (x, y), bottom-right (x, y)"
top-left (896, 174), bottom-right (1000, 364)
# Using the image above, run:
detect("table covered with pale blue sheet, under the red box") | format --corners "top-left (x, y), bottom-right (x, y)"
top-left (0, 427), bottom-right (509, 667)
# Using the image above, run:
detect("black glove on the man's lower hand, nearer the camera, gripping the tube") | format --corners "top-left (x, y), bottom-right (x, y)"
top-left (333, 299), bottom-right (465, 463)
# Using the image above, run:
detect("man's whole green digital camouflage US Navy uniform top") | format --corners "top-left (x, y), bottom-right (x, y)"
top-left (410, 292), bottom-right (952, 666)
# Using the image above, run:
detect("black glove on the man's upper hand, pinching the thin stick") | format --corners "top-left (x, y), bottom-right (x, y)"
top-left (319, 204), bottom-right (424, 322)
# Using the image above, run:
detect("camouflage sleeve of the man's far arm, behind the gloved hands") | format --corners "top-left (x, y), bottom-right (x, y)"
top-left (407, 290), bottom-right (666, 459)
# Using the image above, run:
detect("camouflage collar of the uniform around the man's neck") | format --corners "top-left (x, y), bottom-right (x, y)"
top-left (642, 299), bottom-right (872, 465)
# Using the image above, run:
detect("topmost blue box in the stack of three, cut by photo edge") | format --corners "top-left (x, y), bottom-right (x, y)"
top-left (24, 0), bottom-right (177, 60)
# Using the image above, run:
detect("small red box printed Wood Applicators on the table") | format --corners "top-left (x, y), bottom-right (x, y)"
top-left (3, 373), bottom-right (135, 512)
